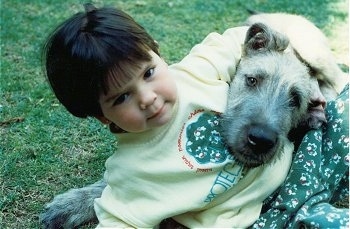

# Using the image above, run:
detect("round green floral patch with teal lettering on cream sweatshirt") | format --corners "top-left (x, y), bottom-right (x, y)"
top-left (178, 110), bottom-right (244, 203)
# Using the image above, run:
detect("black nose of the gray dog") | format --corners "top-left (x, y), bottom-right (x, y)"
top-left (247, 125), bottom-right (277, 153)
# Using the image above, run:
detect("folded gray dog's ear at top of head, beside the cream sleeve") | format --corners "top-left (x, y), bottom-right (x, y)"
top-left (243, 23), bottom-right (289, 55)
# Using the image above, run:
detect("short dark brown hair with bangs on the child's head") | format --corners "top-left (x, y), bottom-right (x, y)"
top-left (42, 4), bottom-right (159, 118)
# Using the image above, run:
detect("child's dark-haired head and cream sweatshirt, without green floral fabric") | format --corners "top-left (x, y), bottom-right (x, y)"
top-left (45, 4), bottom-right (348, 228)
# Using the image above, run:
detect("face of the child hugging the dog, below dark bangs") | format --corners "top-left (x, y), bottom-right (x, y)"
top-left (99, 51), bottom-right (177, 132)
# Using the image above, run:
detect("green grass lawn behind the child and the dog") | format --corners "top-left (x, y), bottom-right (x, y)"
top-left (0, 0), bottom-right (348, 228)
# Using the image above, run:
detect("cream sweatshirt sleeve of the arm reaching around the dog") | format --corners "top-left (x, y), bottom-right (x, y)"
top-left (173, 26), bottom-right (248, 82)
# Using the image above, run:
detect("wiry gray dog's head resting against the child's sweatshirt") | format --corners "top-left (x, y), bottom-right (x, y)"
top-left (222, 23), bottom-right (326, 167)
